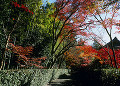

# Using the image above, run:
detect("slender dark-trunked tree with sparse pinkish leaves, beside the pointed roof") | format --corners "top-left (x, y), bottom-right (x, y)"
top-left (86, 0), bottom-right (119, 68)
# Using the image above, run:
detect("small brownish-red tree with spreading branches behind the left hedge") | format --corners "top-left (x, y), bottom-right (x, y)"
top-left (6, 43), bottom-right (46, 69)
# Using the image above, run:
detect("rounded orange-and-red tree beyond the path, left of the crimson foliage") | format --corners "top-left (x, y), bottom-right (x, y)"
top-left (65, 45), bottom-right (100, 68)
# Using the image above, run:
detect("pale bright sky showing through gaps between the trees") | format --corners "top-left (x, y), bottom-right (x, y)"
top-left (43, 0), bottom-right (120, 45)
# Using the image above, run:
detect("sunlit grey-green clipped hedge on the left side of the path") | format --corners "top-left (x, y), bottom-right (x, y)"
top-left (0, 69), bottom-right (68, 86)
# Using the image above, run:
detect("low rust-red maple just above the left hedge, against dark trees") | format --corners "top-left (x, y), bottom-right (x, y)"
top-left (9, 43), bottom-right (46, 69)
